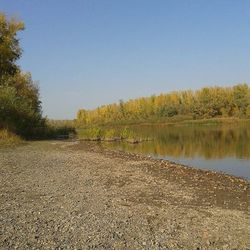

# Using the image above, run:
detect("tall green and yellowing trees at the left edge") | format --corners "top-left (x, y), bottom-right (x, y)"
top-left (0, 13), bottom-right (44, 137)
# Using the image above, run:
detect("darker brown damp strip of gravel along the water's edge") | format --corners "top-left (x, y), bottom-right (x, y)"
top-left (69, 141), bottom-right (250, 212)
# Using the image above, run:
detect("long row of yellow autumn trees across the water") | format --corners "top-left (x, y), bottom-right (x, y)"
top-left (76, 84), bottom-right (250, 126)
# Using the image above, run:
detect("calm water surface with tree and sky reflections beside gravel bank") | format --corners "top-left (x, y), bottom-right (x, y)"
top-left (107, 124), bottom-right (250, 179)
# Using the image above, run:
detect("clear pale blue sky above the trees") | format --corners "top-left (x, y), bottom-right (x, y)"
top-left (0, 0), bottom-right (250, 119)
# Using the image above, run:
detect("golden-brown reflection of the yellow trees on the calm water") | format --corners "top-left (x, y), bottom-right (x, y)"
top-left (111, 125), bottom-right (250, 159)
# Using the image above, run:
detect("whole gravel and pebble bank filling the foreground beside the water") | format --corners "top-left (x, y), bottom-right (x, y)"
top-left (0, 142), bottom-right (250, 249)
